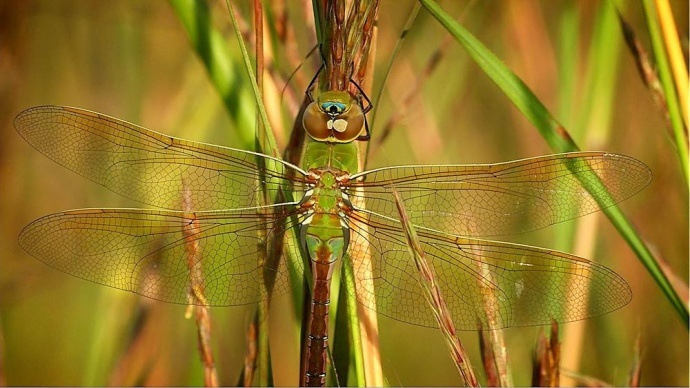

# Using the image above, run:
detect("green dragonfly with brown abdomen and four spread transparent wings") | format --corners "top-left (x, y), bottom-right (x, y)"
top-left (14, 96), bottom-right (651, 385)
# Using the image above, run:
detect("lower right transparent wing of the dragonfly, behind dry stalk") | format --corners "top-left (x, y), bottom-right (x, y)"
top-left (345, 213), bottom-right (632, 330)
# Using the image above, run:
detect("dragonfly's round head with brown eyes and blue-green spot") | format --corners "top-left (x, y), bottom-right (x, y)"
top-left (302, 91), bottom-right (364, 143)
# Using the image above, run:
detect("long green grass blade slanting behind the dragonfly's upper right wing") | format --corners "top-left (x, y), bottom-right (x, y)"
top-left (420, 0), bottom-right (690, 325)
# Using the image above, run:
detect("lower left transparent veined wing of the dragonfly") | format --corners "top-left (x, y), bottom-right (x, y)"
top-left (19, 209), bottom-right (303, 306)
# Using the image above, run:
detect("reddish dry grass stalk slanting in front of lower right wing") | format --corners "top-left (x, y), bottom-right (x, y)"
top-left (393, 190), bottom-right (479, 387)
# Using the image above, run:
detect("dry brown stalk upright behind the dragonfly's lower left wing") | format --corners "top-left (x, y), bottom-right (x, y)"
top-left (182, 183), bottom-right (218, 387)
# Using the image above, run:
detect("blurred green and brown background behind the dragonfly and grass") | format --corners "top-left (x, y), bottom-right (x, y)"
top-left (0, 0), bottom-right (689, 385)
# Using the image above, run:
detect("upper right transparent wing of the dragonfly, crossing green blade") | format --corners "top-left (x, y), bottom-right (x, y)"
top-left (347, 152), bottom-right (652, 236)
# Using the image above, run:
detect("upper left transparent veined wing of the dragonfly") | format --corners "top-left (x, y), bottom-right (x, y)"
top-left (14, 106), bottom-right (304, 211)
